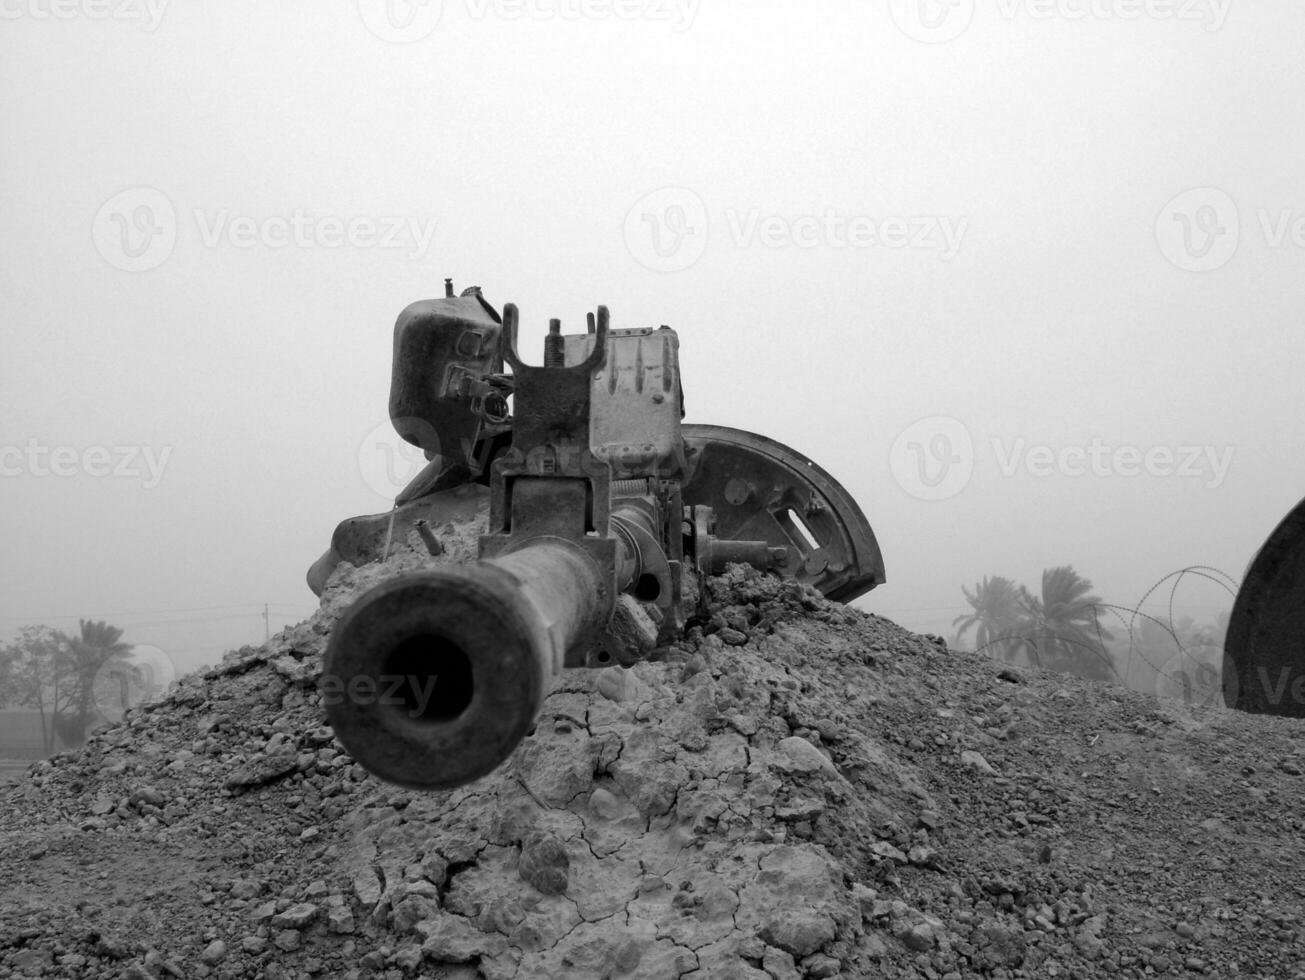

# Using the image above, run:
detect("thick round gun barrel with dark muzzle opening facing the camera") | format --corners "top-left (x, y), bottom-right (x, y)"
top-left (322, 538), bottom-right (604, 789)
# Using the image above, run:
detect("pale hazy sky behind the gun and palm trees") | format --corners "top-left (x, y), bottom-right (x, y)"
top-left (0, 0), bottom-right (1305, 668)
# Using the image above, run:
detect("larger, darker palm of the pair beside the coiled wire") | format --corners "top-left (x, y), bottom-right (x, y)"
top-left (1017, 565), bottom-right (1118, 681)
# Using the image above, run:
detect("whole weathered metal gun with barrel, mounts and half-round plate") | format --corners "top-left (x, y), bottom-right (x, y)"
top-left (308, 281), bottom-right (885, 789)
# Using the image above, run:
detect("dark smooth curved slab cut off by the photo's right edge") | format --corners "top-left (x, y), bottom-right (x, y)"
top-left (1223, 500), bottom-right (1305, 718)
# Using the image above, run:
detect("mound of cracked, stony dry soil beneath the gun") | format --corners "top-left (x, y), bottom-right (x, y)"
top-left (0, 514), bottom-right (1305, 980)
